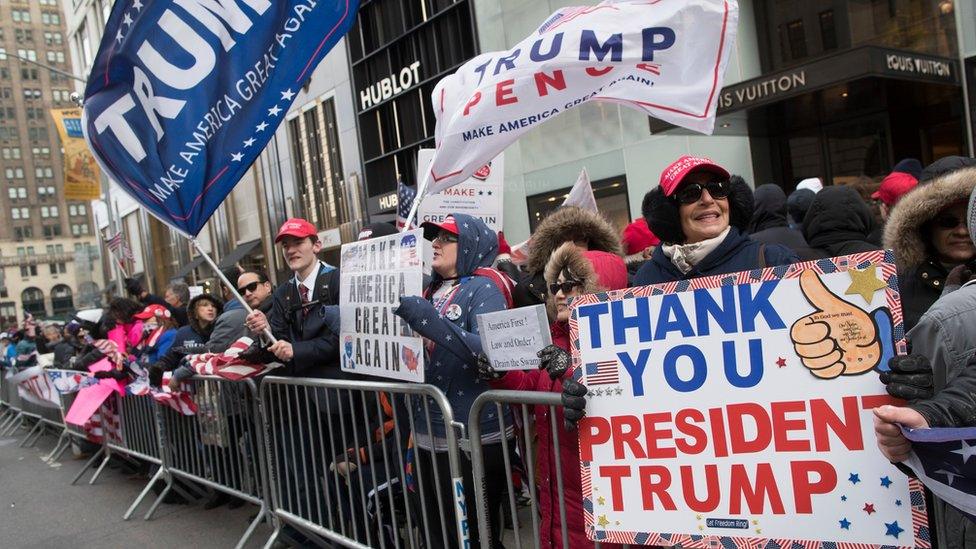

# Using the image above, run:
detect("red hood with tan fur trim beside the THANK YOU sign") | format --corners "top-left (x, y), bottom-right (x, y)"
top-left (546, 242), bottom-right (627, 298)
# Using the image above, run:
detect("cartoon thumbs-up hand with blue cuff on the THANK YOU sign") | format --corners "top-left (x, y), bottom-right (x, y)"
top-left (790, 269), bottom-right (894, 379)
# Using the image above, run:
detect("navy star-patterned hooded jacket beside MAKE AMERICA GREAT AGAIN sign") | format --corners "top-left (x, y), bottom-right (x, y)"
top-left (394, 214), bottom-right (512, 444)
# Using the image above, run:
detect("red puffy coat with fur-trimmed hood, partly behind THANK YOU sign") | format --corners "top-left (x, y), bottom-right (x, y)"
top-left (492, 244), bottom-right (627, 549)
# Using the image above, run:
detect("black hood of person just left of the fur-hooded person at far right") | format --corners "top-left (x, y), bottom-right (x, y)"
top-left (803, 186), bottom-right (881, 257)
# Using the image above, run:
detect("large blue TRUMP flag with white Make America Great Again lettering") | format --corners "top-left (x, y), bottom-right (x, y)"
top-left (83, 0), bottom-right (359, 236)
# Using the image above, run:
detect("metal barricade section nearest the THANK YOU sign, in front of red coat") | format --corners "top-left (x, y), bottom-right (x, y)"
top-left (468, 391), bottom-right (617, 549)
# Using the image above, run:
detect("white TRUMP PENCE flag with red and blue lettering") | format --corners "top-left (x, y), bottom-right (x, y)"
top-left (421, 0), bottom-right (738, 198)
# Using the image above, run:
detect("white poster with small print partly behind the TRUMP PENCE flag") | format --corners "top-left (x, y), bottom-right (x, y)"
top-left (417, 149), bottom-right (505, 233)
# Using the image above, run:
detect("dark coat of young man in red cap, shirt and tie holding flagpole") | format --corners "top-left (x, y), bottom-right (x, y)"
top-left (268, 263), bottom-right (346, 379)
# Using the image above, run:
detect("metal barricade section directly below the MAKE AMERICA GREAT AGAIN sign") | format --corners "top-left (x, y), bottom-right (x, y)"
top-left (261, 377), bottom-right (468, 548)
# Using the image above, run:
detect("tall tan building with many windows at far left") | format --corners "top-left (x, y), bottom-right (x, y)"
top-left (0, 0), bottom-right (104, 327)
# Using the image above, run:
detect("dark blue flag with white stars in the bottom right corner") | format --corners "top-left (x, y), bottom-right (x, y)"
top-left (902, 427), bottom-right (976, 521)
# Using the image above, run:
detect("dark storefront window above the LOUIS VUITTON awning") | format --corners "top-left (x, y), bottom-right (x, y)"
top-left (756, 0), bottom-right (956, 72)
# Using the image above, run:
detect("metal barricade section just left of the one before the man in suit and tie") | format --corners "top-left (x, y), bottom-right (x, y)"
top-left (157, 376), bottom-right (271, 547)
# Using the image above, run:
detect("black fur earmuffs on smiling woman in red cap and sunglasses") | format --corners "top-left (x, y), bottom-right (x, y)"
top-left (641, 175), bottom-right (753, 244)
